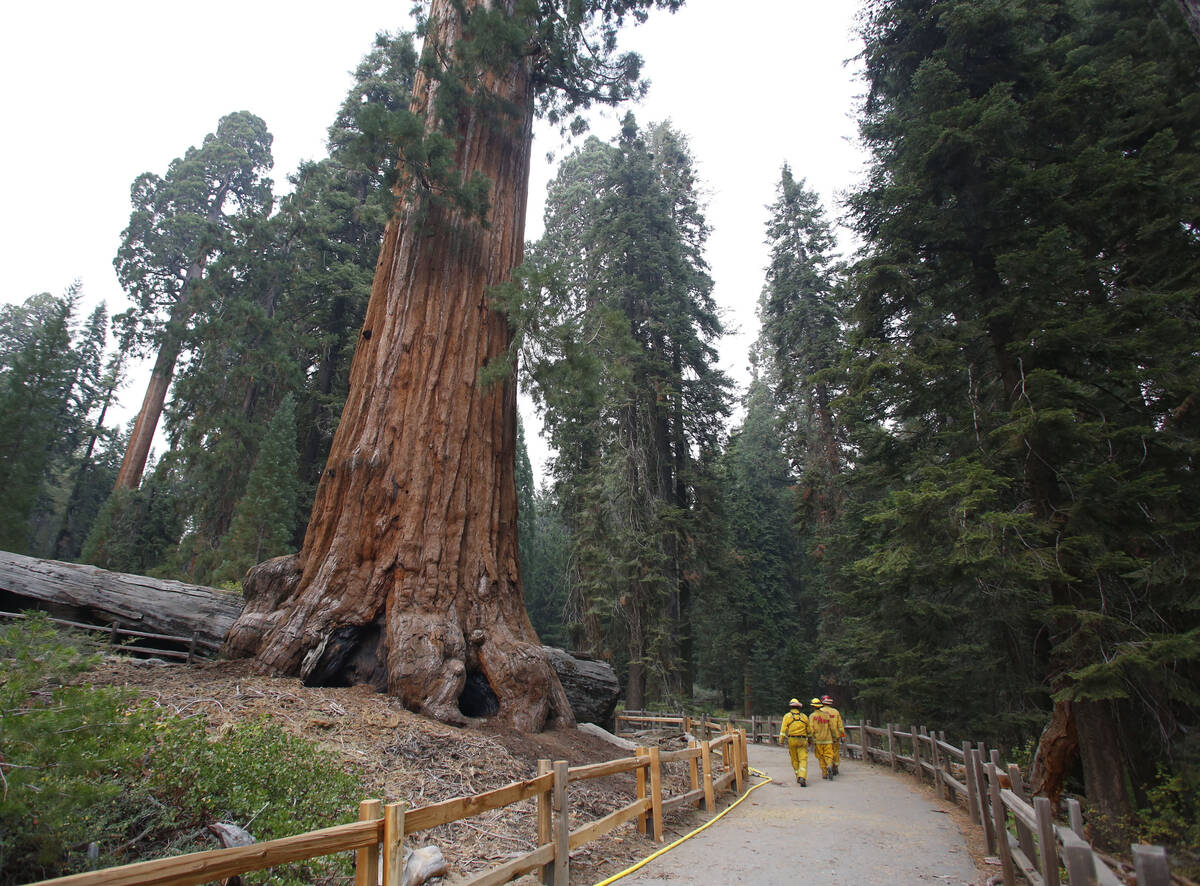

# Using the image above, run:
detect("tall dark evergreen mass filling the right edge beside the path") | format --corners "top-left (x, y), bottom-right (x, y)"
top-left (850, 0), bottom-right (1200, 816)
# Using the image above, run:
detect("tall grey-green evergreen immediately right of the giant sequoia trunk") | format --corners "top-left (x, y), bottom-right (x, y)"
top-left (517, 116), bottom-right (727, 706)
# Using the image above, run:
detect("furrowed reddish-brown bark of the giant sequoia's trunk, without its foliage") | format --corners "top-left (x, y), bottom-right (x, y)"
top-left (226, 0), bottom-right (574, 731)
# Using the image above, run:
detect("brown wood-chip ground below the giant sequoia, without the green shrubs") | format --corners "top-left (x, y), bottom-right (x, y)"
top-left (86, 655), bottom-right (702, 884)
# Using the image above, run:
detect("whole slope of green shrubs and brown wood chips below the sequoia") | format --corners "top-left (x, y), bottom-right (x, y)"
top-left (0, 621), bottom-right (694, 885)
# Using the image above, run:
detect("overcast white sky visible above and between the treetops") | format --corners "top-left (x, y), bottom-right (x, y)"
top-left (0, 0), bottom-right (864, 475)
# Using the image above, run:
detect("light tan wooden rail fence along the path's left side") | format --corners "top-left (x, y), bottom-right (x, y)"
top-left (30, 722), bottom-right (750, 886)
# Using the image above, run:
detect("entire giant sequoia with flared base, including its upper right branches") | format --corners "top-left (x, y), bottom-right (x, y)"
top-left (226, 0), bottom-right (682, 731)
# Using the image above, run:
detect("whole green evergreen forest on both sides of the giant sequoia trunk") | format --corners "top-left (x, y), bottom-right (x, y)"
top-left (0, 0), bottom-right (1200, 839)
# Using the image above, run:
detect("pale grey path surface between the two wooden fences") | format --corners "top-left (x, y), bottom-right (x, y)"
top-left (618, 744), bottom-right (988, 886)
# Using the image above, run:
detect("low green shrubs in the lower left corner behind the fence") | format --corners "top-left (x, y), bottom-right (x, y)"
top-left (0, 613), bottom-right (360, 884)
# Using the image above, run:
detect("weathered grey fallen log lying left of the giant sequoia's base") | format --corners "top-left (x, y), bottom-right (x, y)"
top-left (0, 551), bottom-right (242, 647)
